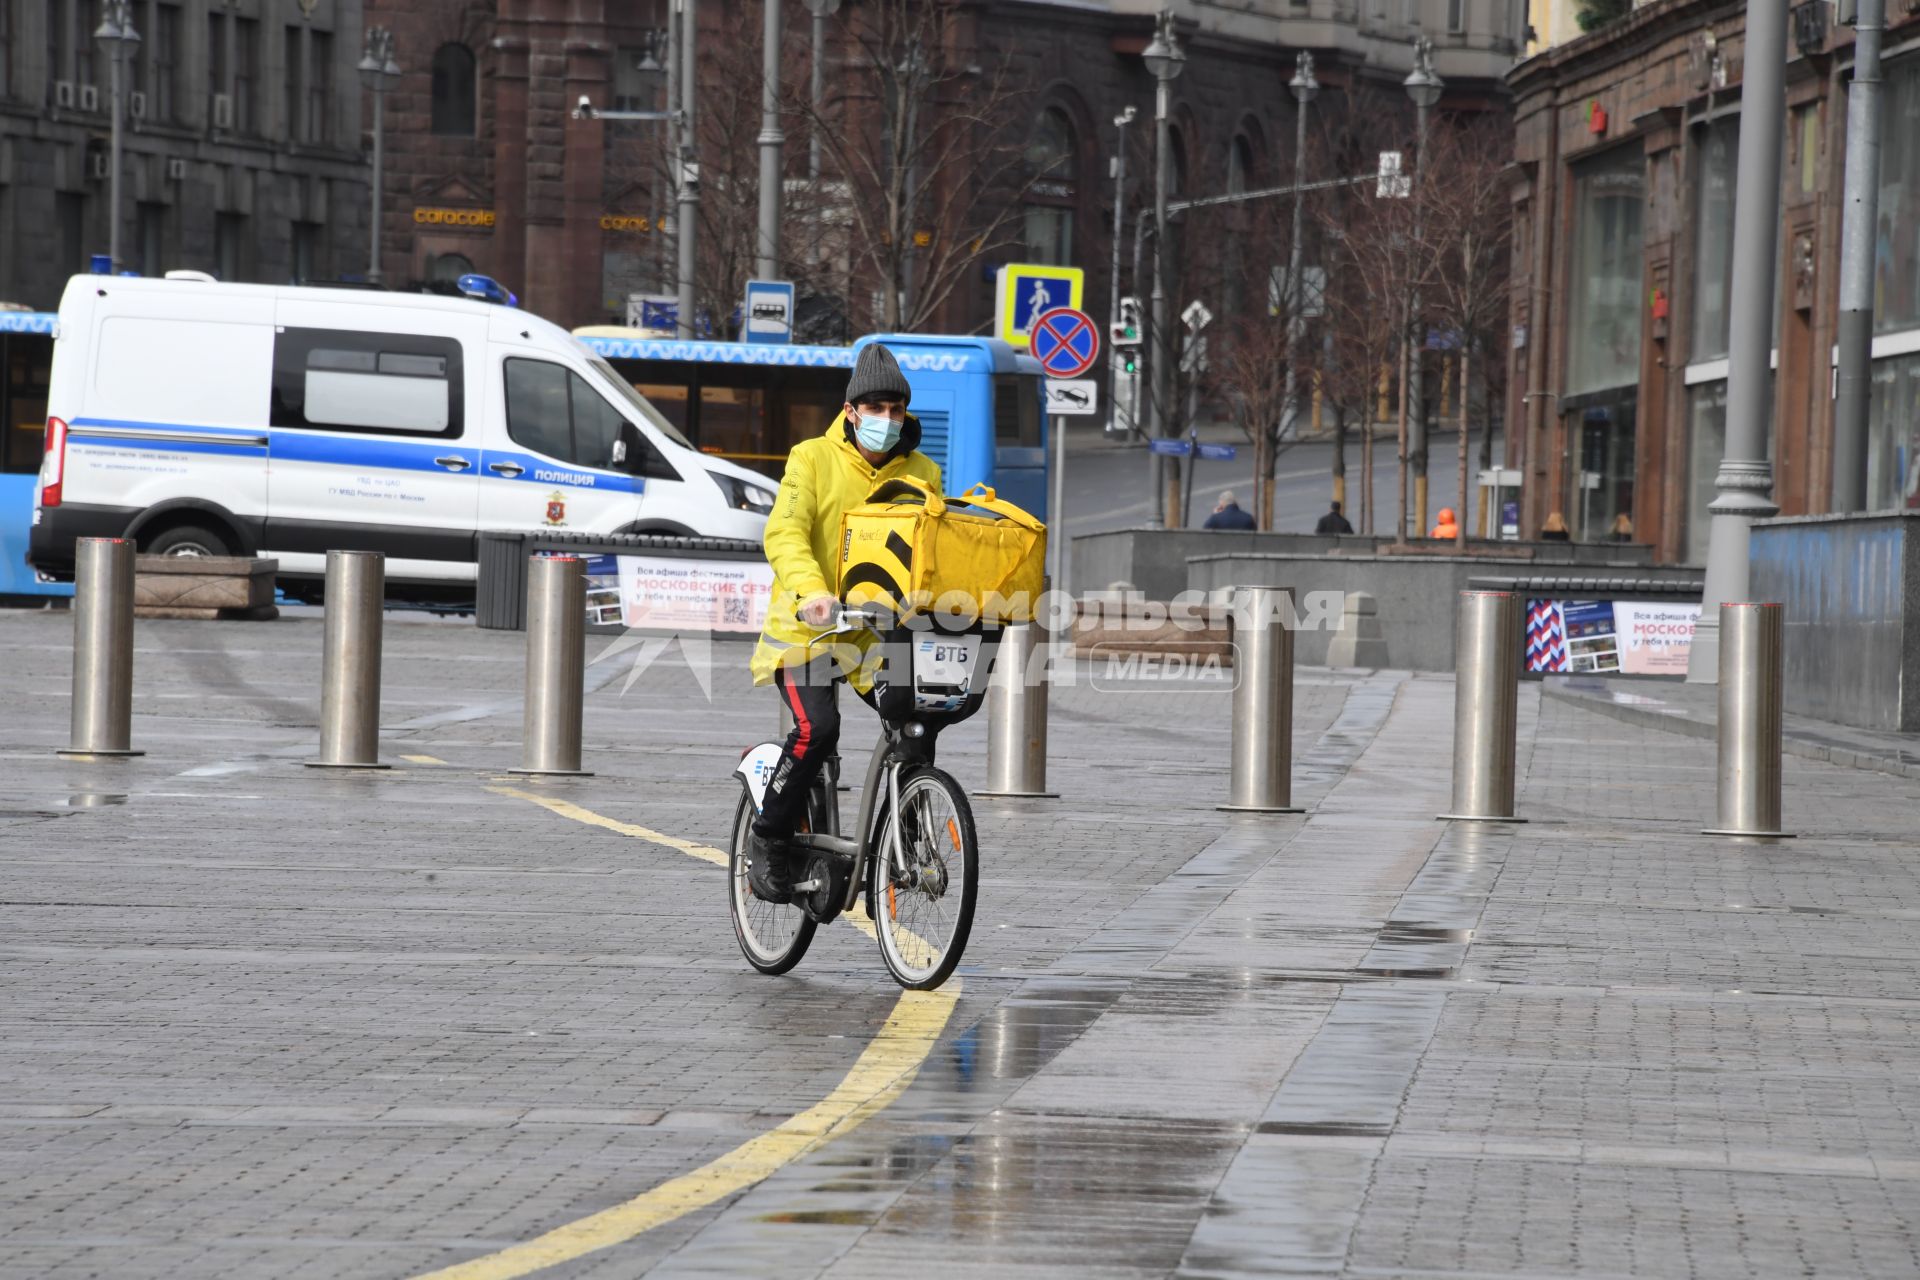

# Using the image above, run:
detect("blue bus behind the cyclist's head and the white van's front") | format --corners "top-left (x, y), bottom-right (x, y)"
top-left (574, 335), bottom-right (1048, 520)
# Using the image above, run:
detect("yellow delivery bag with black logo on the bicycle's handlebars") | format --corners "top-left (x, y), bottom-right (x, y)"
top-left (839, 476), bottom-right (1046, 622)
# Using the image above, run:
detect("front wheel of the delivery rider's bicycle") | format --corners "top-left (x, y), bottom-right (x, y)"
top-left (872, 768), bottom-right (979, 990)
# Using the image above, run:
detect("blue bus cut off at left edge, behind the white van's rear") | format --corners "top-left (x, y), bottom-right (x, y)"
top-left (0, 309), bottom-right (73, 599)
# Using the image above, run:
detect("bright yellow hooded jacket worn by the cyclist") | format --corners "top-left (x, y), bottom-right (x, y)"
top-left (751, 413), bottom-right (941, 689)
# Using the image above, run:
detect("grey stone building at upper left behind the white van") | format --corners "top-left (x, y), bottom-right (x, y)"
top-left (0, 0), bottom-right (369, 309)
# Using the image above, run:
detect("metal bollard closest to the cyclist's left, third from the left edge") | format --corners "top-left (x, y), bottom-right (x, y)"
top-left (515, 557), bottom-right (591, 777)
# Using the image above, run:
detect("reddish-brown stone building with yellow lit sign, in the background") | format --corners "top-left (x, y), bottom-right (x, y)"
top-left (367, 0), bottom-right (1526, 332)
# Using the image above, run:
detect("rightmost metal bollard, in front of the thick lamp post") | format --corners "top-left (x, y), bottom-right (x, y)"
top-left (1705, 604), bottom-right (1789, 839)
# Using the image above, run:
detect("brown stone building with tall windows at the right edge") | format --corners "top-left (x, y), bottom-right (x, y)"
top-left (1507, 0), bottom-right (1920, 562)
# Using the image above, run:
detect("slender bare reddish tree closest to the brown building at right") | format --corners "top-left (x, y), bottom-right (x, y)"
top-left (1421, 117), bottom-right (1513, 547)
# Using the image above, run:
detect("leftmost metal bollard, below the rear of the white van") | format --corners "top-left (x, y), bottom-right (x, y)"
top-left (60, 537), bottom-right (146, 756)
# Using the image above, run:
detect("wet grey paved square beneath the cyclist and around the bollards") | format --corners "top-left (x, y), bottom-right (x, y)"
top-left (0, 612), bottom-right (1920, 1280)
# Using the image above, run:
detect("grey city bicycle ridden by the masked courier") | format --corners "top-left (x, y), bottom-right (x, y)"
top-left (728, 606), bottom-right (998, 990)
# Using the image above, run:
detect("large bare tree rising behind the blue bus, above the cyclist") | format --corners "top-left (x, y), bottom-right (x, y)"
top-left (793, 0), bottom-right (1031, 330)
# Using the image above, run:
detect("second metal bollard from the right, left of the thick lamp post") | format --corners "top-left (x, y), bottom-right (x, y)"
top-left (1440, 591), bottom-right (1526, 821)
